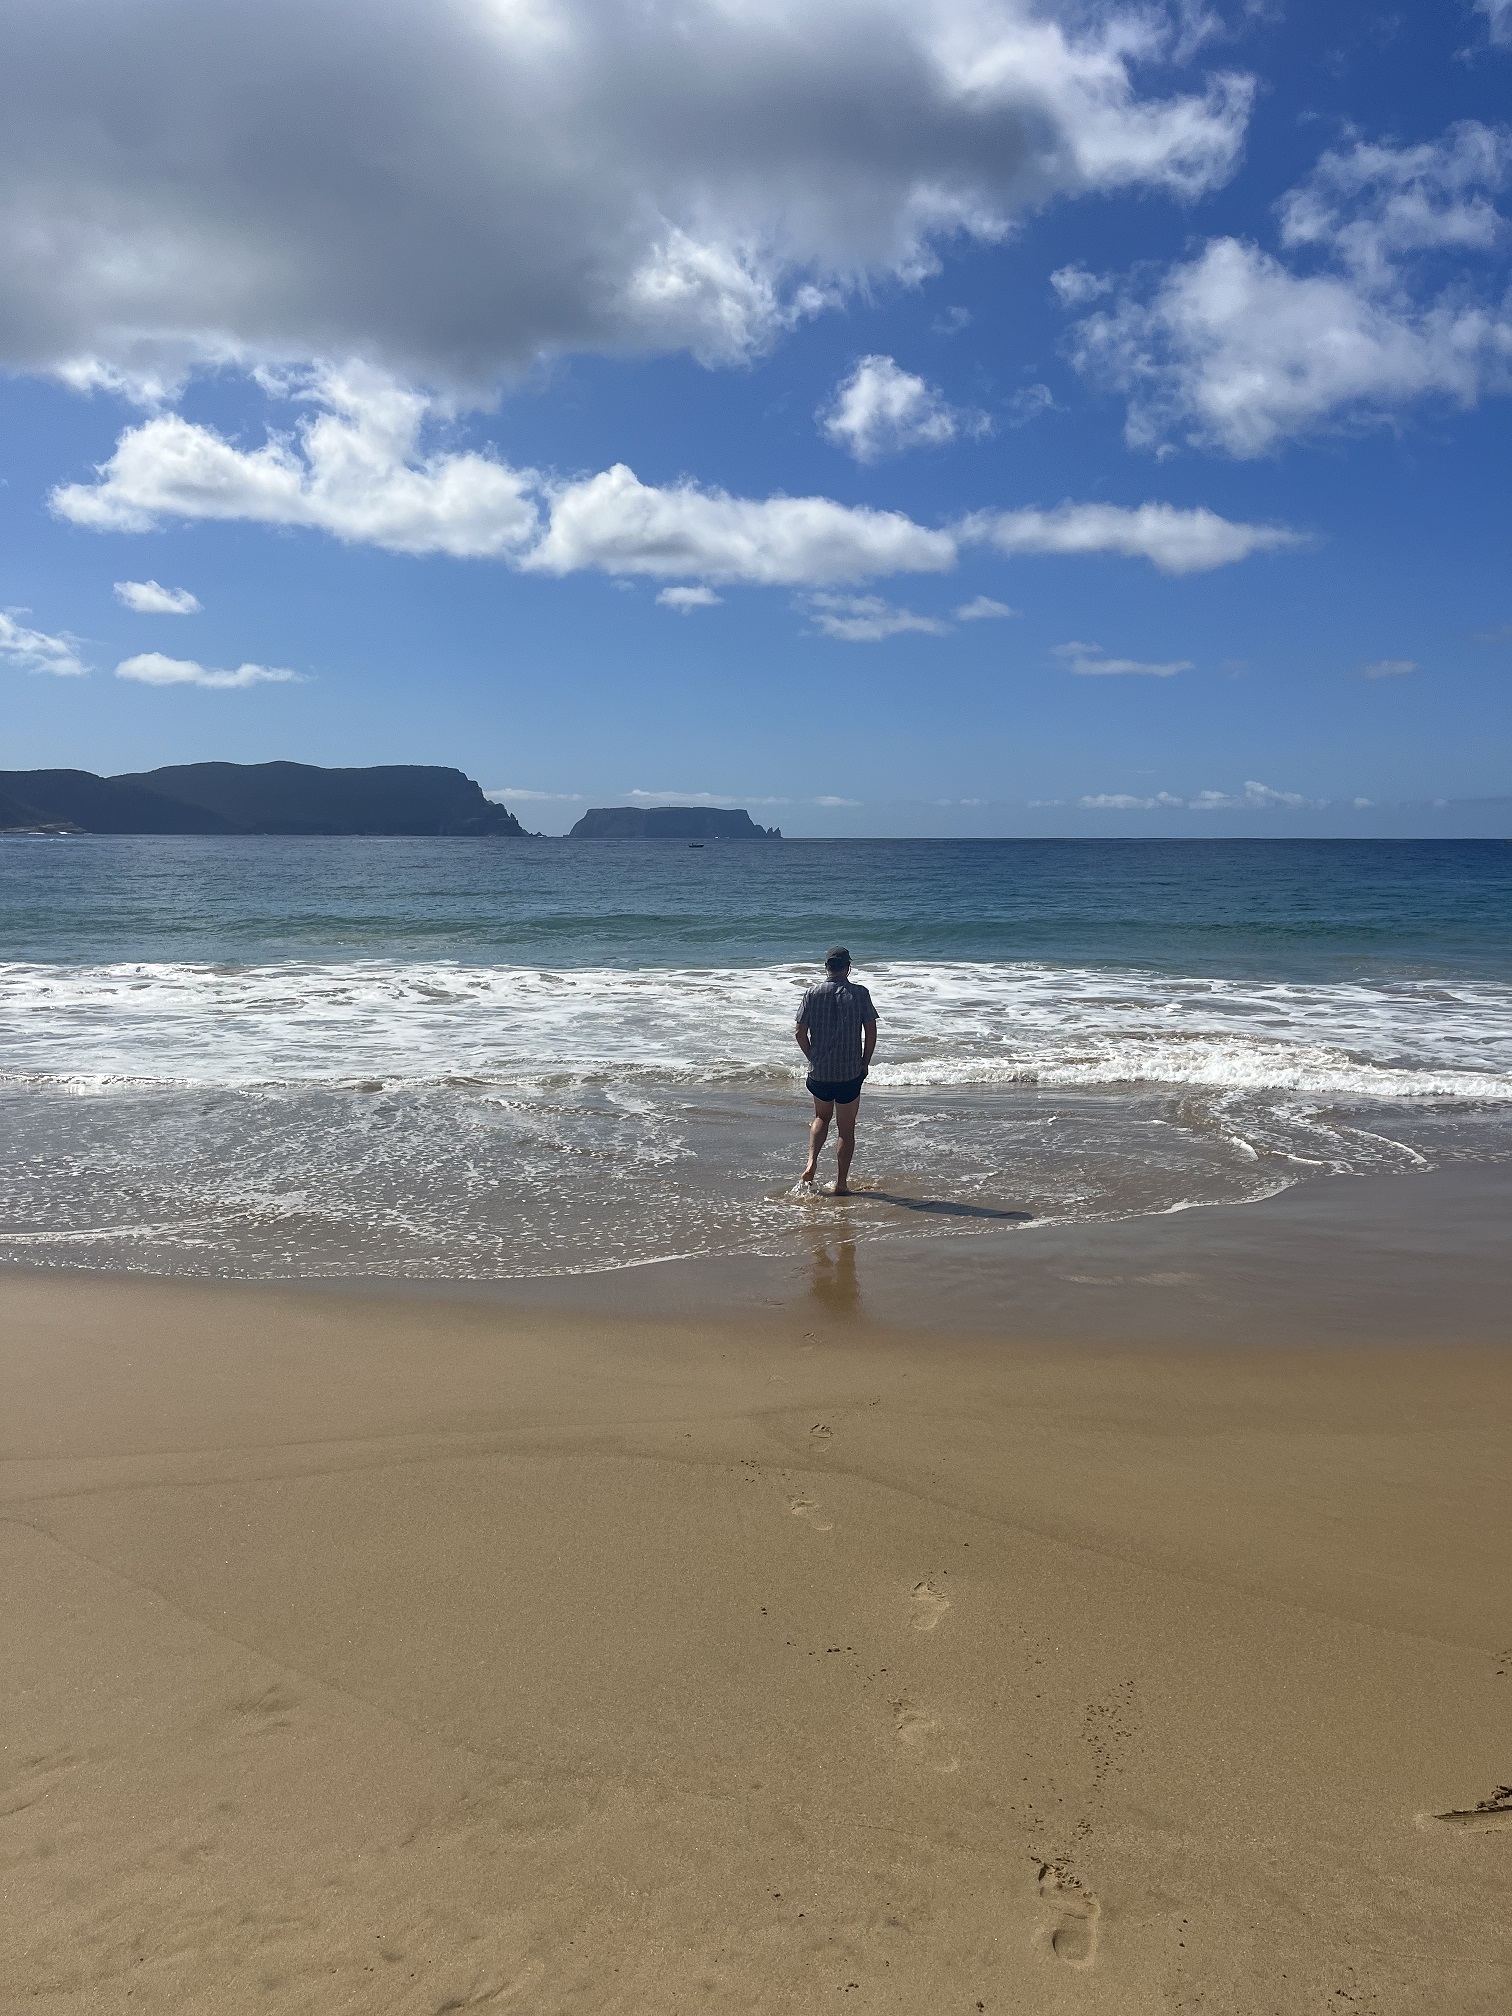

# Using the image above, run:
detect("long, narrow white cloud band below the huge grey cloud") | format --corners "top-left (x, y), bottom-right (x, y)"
top-left (52, 369), bottom-right (1294, 584)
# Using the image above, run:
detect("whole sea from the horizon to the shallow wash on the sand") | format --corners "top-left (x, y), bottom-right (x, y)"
top-left (0, 837), bottom-right (1512, 1278)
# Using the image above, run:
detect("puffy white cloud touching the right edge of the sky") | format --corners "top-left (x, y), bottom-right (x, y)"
top-left (1073, 121), bottom-right (1512, 456)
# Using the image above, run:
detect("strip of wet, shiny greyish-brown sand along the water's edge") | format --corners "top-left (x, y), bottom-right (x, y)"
top-left (0, 1161), bottom-right (1512, 1347)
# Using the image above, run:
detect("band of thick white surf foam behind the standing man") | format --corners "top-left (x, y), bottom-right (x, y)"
top-left (0, 960), bottom-right (1512, 1103)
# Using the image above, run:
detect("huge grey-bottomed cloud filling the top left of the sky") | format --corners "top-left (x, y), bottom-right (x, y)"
top-left (0, 0), bottom-right (1250, 391)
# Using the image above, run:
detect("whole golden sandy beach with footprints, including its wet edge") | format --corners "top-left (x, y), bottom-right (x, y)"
top-left (0, 1179), bottom-right (1512, 2016)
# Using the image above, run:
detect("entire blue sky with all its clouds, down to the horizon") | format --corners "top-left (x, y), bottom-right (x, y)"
top-left (0, 0), bottom-right (1512, 835)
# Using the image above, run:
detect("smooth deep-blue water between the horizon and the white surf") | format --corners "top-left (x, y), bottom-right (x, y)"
top-left (0, 839), bottom-right (1512, 980)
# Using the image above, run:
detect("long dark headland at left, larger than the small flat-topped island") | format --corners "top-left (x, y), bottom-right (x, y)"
top-left (0, 762), bottom-right (528, 839)
